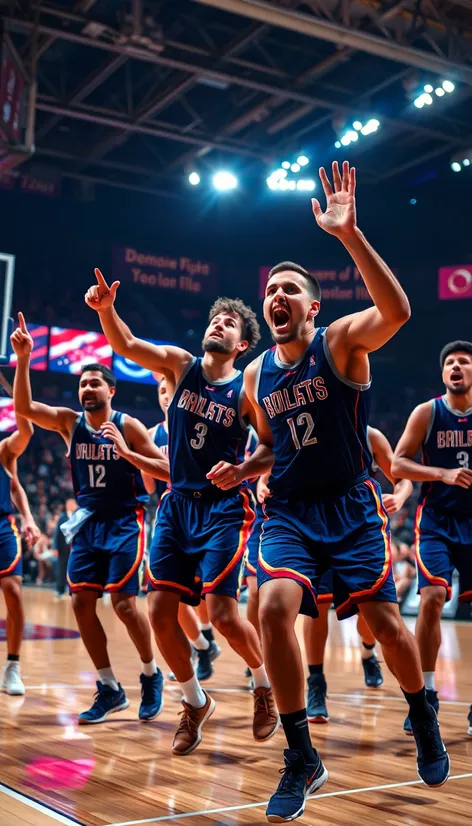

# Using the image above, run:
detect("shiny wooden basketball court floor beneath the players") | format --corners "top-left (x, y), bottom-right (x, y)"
top-left (0, 589), bottom-right (472, 826)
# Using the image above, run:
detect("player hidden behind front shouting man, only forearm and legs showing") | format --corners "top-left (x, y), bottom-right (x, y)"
top-left (303, 426), bottom-right (413, 723)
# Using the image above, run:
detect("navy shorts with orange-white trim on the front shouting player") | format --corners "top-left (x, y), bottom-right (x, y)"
top-left (257, 479), bottom-right (397, 619)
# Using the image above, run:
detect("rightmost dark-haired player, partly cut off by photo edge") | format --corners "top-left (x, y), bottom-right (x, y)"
top-left (393, 341), bottom-right (472, 734)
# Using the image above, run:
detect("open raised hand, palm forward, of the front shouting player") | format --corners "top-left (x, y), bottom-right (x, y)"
top-left (311, 161), bottom-right (357, 239)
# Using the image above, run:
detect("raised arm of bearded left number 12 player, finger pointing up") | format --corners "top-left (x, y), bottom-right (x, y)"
top-left (10, 313), bottom-right (77, 440)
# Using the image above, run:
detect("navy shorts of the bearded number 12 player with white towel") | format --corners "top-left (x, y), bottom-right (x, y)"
top-left (67, 508), bottom-right (146, 594)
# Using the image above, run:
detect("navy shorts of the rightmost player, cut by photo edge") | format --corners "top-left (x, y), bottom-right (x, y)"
top-left (415, 504), bottom-right (472, 602)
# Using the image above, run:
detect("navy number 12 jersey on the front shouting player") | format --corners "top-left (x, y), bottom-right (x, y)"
top-left (256, 327), bottom-right (372, 497)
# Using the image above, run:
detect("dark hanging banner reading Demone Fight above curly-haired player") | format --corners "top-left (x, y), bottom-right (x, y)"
top-left (113, 247), bottom-right (218, 295)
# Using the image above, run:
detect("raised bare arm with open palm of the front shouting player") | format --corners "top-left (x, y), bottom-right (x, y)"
top-left (312, 161), bottom-right (410, 355)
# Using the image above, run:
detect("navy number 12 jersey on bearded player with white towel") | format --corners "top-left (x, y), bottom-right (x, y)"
top-left (70, 410), bottom-right (149, 511)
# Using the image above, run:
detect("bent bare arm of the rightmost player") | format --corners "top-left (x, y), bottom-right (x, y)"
top-left (392, 401), bottom-right (472, 488)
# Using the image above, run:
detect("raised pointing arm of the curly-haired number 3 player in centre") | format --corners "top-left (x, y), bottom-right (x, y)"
top-left (85, 269), bottom-right (192, 380)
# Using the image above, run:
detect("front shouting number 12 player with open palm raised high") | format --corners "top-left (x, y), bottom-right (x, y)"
top-left (245, 162), bottom-right (449, 821)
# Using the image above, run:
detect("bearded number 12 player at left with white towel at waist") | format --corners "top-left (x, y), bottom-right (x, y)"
top-left (11, 313), bottom-right (168, 724)
